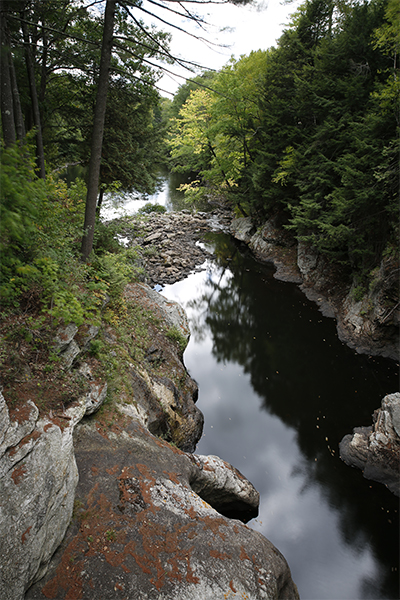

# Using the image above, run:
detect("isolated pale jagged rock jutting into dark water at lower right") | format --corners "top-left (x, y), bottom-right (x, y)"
top-left (339, 392), bottom-right (400, 496)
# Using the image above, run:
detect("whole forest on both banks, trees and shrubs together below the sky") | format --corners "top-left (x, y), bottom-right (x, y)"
top-left (0, 0), bottom-right (400, 324)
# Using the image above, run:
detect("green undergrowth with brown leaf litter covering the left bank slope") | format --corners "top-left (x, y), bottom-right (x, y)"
top-left (0, 145), bottom-right (151, 412)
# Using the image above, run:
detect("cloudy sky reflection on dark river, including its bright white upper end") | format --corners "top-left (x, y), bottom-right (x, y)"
top-left (162, 250), bottom-right (394, 600)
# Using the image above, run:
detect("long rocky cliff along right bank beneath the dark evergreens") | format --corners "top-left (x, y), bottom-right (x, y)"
top-left (231, 218), bottom-right (400, 360)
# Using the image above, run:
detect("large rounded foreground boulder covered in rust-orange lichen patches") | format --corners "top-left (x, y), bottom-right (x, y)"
top-left (26, 420), bottom-right (299, 600)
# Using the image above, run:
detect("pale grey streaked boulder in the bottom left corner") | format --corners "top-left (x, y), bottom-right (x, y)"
top-left (0, 382), bottom-right (109, 600)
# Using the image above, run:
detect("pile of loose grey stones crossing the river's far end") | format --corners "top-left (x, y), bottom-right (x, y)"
top-left (120, 210), bottom-right (231, 286)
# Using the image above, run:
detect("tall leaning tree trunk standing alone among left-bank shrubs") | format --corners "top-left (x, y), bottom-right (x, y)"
top-left (81, 0), bottom-right (116, 261)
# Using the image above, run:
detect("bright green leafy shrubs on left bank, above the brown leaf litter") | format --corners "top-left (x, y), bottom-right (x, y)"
top-left (0, 139), bottom-right (142, 327)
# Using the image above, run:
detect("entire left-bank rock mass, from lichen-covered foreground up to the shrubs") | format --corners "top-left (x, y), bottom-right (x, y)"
top-left (0, 284), bottom-right (298, 600)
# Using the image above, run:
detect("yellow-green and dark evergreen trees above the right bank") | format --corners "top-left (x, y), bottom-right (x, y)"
top-left (165, 0), bottom-right (400, 275)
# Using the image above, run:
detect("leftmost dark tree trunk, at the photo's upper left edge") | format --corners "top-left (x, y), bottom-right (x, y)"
top-left (0, 2), bottom-right (16, 146)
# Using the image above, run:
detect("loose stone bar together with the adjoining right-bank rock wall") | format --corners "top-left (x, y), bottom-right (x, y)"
top-left (120, 210), bottom-right (400, 360)
